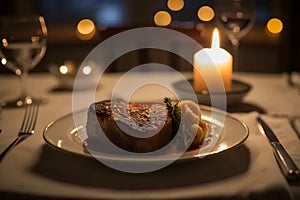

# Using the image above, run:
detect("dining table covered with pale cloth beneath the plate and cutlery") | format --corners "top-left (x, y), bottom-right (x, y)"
top-left (0, 71), bottom-right (300, 200)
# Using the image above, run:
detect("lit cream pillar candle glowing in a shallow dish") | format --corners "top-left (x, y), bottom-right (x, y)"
top-left (193, 29), bottom-right (232, 93)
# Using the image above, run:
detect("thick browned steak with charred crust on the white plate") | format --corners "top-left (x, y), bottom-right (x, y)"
top-left (86, 101), bottom-right (173, 153)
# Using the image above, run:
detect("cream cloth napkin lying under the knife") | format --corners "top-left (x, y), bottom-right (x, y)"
top-left (229, 112), bottom-right (300, 199)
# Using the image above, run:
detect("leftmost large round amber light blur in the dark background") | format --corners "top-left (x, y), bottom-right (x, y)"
top-left (76, 19), bottom-right (96, 40)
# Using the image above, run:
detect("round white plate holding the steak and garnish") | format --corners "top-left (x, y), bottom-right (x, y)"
top-left (43, 106), bottom-right (249, 162)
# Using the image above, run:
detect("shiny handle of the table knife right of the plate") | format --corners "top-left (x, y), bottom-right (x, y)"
top-left (271, 142), bottom-right (300, 180)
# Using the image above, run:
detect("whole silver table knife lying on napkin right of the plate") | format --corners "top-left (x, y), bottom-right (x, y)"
top-left (257, 117), bottom-right (300, 180)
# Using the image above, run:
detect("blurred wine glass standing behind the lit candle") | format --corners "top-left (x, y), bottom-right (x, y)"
top-left (215, 0), bottom-right (255, 71)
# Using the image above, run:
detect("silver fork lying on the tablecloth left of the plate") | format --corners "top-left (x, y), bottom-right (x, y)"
top-left (0, 103), bottom-right (39, 162)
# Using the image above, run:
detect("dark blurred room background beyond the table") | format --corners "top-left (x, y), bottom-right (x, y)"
top-left (0, 0), bottom-right (300, 73)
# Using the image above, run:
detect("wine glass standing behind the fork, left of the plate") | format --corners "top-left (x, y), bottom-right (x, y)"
top-left (0, 15), bottom-right (47, 108)
